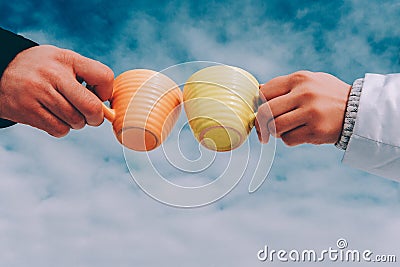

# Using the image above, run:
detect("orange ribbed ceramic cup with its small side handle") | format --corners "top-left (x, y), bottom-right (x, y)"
top-left (103, 69), bottom-right (182, 151)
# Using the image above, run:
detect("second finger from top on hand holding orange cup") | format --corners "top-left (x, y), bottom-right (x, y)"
top-left (57, 78), bottom-right (104, 126)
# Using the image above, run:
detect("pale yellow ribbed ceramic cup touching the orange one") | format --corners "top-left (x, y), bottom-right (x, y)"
top-left (183, 65), bottom-right (259, 151)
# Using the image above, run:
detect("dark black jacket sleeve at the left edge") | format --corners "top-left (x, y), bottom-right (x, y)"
top-left (0, 28), bottom-right (38, 128)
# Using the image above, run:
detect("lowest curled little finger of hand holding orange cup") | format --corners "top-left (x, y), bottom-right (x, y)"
top-left (30, 107), bottom-right (70, 138)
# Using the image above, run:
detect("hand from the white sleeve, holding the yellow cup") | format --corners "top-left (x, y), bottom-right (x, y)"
top-left (256, 71), bottom-right (351, 146)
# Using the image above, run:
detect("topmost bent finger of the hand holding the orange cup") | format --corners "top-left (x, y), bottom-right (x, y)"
top-left (71, 52), bottom-right (114, 101)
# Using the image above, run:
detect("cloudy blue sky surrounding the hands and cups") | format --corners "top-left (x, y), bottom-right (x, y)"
top-left (0, 0), bottom-right (400, 266)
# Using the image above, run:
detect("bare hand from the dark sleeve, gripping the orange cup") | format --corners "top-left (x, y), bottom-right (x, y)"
top-left (0, 45), bottom-right (114, 137)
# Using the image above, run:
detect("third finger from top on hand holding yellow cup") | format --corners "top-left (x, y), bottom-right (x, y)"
top-left (268, 109), bottom-right (307, 137)
